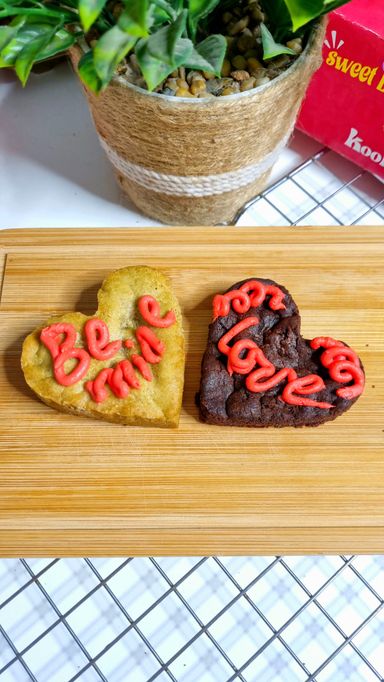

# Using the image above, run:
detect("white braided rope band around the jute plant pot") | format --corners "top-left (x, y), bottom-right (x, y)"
top-left (99, 126), bottom-right (293, 197)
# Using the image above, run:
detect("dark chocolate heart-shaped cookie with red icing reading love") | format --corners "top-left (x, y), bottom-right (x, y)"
top-left (199, 278), bottom-right (365, 427)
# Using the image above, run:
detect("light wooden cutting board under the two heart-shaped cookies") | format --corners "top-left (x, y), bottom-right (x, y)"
top-left (0, 227), bottom-right (384, 556)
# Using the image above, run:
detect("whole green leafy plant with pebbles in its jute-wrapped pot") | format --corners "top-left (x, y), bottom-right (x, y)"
top-left (0, 0), bottom-right (354, 225)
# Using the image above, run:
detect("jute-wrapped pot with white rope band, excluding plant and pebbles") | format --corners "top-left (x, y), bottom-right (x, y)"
top-left (70, 21), bottom-right (325, 225)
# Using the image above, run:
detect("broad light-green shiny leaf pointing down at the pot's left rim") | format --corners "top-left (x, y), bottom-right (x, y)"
top-left (93, 26), bottom-right (137, 87)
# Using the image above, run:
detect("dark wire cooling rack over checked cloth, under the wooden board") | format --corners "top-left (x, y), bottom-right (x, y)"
top-left (0, 131), bottom-right (384, 682)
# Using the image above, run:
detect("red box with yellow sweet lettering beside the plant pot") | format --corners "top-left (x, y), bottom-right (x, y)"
top-left (297, 0), bottom-right (384, 178)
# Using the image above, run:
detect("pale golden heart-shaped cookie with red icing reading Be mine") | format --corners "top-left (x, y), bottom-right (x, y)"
top-left (21, 266), bottom-right (184, 427)
